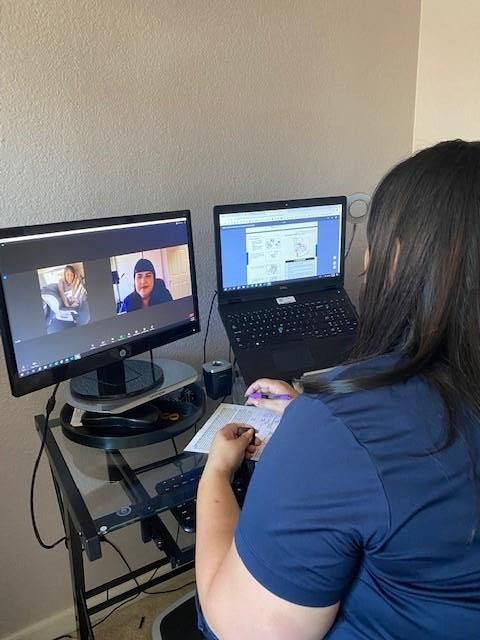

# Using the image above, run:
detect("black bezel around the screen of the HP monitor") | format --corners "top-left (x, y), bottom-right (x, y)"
top-left (0, 209), bottom-right (200, 397)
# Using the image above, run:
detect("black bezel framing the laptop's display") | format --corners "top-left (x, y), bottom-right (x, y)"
top-left (213, 196), bottom-right (347, 303)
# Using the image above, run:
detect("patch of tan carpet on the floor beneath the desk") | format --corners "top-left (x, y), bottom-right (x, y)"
top-left (65, 570), bottom-right (195, 640)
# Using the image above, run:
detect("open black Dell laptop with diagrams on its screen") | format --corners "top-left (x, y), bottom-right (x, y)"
top-left (213, 196), bottom-right (357, 385)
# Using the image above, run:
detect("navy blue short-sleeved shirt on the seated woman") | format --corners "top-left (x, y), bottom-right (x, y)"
top-left (235, 354), bottom-right (480, 640)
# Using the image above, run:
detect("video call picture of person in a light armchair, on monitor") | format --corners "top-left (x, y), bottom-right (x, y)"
top-left (37, 262), bottom-right (90, 334)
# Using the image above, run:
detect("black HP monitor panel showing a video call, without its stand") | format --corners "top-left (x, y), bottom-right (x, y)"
top-left (0, 211), bottom-right (199, 395)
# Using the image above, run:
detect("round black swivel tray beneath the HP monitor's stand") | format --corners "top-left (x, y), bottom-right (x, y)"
top-left (60, 383), bottom-right (205, 450)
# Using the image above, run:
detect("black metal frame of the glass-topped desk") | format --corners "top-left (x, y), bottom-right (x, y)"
top-left (35, 415), bottom-right (201, 640)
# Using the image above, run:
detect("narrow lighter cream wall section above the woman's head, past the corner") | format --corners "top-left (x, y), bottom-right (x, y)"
top-left (414, 0), bottom-right (480, 148)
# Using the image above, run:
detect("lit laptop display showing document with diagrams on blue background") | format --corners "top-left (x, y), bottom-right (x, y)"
top-left (218, 201), bottom-right (344, 291)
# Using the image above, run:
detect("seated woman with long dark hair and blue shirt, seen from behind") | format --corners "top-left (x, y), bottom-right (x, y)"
top-left (196, 140), bottom-right (480, 640)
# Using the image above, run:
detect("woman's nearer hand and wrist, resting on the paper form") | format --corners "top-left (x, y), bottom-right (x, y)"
top-left (205, 423), bottom-right (262, 476)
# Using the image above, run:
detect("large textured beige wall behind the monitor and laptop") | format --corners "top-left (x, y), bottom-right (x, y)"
top-left (0, 0), bottom-right (420, 637)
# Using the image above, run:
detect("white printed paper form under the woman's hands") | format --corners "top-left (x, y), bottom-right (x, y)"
top-left (185, 403), bottom-right (281, 460)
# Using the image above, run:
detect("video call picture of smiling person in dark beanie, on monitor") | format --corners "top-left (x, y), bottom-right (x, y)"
top-left (110, 244), bottom-right (192, 314)
